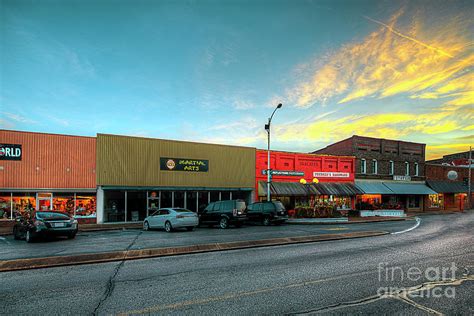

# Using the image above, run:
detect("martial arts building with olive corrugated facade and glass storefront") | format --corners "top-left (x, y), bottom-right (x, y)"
top-left (97, 134), bottom-right (255, 223)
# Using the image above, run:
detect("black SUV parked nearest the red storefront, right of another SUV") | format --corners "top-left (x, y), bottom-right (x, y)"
top-left (247, 201), bottom-right (288, 226)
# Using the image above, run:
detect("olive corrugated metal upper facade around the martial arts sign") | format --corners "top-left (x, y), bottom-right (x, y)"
top-left (97, 134), bottom-right (255, 188)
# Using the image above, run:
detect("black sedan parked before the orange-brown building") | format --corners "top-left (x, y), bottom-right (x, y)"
top-left (13, 211), bottom-right (79, 242)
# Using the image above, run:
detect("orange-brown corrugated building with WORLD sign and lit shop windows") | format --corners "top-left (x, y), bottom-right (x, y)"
top-left (0, 130), bottom-right (96, 222)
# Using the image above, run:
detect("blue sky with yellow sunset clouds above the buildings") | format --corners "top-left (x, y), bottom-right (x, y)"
top-left (0, 0), bottom-right (474, 159)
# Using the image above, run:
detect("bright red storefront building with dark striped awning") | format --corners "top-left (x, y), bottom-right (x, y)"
top-left (255, 150), bottom-right (361, 210)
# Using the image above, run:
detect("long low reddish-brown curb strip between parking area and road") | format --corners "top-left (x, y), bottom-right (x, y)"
top-left (0, 231), bottom-right (390, 272)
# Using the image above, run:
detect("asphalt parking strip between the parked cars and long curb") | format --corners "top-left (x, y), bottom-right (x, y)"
top-left (0, 220), bottom-right (414, 260)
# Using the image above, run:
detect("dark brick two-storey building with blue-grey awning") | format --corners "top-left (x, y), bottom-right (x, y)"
top-left (313, 135), bottom-right (436, 211)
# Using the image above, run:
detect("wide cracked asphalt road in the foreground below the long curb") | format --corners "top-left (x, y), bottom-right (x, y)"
top-left (0, 212), bottom-right (474, 315)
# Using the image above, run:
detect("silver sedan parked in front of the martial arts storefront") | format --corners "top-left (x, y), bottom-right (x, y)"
top-left (143, 208), bottom-right (199, 232)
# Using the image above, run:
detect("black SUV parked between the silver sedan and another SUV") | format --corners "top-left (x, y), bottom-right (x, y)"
top-left (199, 200), bottom-right (247, 228)
